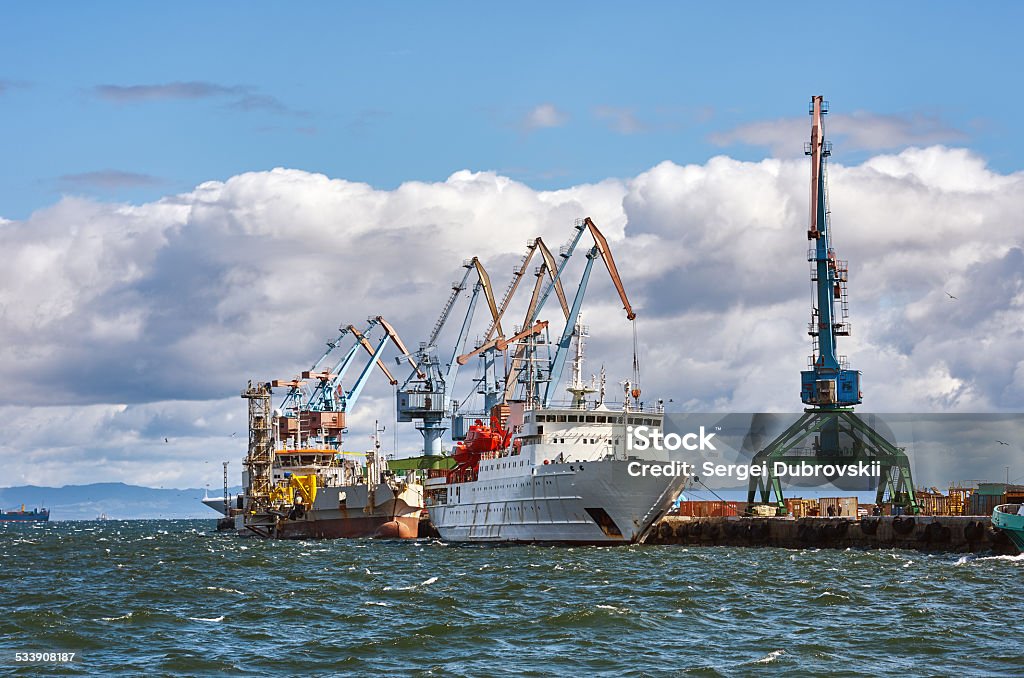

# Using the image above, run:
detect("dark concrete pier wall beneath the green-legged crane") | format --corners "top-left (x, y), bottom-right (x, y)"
top-left (646, 516), bottom-right (1019, 555)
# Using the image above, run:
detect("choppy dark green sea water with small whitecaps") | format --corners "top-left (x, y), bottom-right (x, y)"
top-left (0, 521), bottom-right (1024, 676)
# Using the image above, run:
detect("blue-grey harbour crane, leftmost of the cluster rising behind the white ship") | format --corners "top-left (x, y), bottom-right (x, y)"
top-left (396, 257), bottom-right (503, 456)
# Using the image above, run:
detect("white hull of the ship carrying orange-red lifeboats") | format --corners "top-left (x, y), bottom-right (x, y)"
top-left (428, 460), bottom-right (687, 545)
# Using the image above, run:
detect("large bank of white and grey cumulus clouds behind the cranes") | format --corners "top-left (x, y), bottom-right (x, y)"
top-left (0, 148), bottom-right (1024, 486)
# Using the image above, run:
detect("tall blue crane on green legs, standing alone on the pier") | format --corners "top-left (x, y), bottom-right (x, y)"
top-left (746, 95), bottom-right (920, 515)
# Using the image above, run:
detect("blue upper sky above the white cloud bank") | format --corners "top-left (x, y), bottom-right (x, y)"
top-left (0, 2), bottom-right (1024, 218)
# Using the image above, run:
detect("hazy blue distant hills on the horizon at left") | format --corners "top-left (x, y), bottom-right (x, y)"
top-left (0, 482), bottom-right (241, 520)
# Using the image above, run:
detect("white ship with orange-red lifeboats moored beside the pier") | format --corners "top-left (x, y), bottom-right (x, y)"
top-left (424, 327), bottom-right (688, 544)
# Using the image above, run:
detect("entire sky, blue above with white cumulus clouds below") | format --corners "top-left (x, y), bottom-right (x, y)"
top-left (0, 3), bottom-right (1024, 486)
